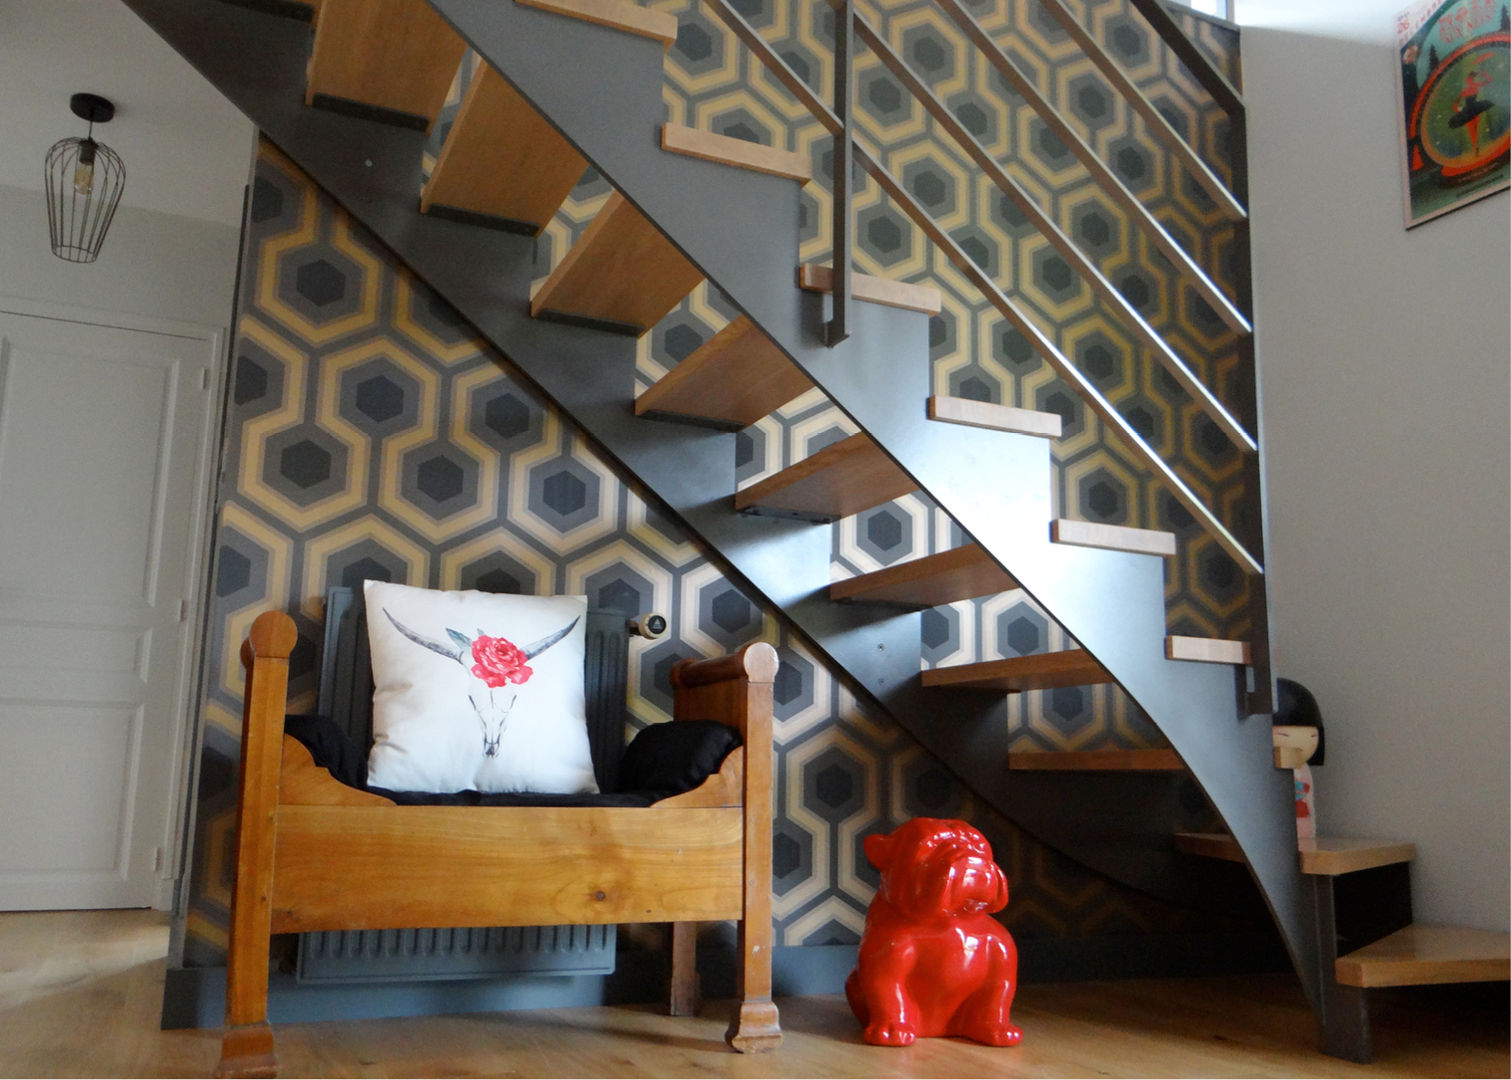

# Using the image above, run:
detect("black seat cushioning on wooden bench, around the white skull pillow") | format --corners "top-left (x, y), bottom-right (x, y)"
top-left (284, 714), bottom-right (740, 807)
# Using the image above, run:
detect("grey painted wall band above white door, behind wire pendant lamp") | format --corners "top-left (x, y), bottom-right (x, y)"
top-left (0, 182), bottom-right (241, 328)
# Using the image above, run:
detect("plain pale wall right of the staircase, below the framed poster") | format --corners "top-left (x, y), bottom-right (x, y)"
top-left (1238, 0), bottom-right (1511, 929)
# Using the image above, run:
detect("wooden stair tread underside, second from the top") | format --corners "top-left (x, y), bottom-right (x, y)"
top-left (420, 68), bottom-right (588, 236)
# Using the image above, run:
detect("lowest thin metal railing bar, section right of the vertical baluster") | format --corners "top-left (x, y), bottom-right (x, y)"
top-left (855, 137), bottom-right (1265, 574)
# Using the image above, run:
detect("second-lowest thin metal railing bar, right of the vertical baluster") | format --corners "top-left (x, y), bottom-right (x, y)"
top-left (855, 6), bottom-right (1257, 452)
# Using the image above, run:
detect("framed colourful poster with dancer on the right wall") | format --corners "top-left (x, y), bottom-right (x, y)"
top-left (1396, 0), bottom-right (1511, 228)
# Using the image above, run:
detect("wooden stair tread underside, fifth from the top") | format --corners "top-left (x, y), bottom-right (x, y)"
top-left (734, 435), bottom-right (917, 521)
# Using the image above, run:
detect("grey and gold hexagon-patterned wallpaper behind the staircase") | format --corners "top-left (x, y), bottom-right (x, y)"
top-left (184, 0), bottom-right (1247, 964)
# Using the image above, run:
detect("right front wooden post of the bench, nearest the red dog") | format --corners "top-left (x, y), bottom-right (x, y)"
top-left (671, 642), bottom-right (781, 1053)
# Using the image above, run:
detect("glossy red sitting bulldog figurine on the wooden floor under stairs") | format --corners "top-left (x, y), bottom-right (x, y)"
top-left (845, 817), bottom-right (1023, 1047)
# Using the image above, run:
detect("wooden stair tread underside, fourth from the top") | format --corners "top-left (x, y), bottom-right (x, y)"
top-left (635, 316), bottom-right (813, 430)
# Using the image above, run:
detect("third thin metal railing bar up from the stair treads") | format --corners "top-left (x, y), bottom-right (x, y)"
top-left (934, 0), bottom-right (1254, 334)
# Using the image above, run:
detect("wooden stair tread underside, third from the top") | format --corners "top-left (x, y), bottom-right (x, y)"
top-left (530, 192), bottom-right (703, 335)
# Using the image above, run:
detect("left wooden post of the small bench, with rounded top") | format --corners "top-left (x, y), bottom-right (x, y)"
top-left (215, 612), bottom-right (299, 1077)
